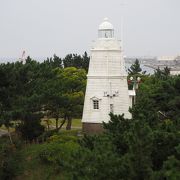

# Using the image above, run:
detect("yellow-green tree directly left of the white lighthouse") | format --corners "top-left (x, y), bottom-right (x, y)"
top-left (57, 67), bottom-right (86, 130)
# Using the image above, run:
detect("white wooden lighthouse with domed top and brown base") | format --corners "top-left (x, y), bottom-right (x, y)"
top-left (82, 18), bottom-right (131, 133)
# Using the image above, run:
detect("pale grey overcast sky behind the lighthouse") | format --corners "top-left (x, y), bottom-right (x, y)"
top-left (0, 0), bottom-right (180, 60)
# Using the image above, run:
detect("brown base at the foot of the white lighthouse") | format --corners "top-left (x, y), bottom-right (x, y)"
top-left (82, 123), bottom-right (104, 134)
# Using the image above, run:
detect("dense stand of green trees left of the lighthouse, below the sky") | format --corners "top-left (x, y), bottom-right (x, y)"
top-left (0, 53), bottom-right (89, 140)
